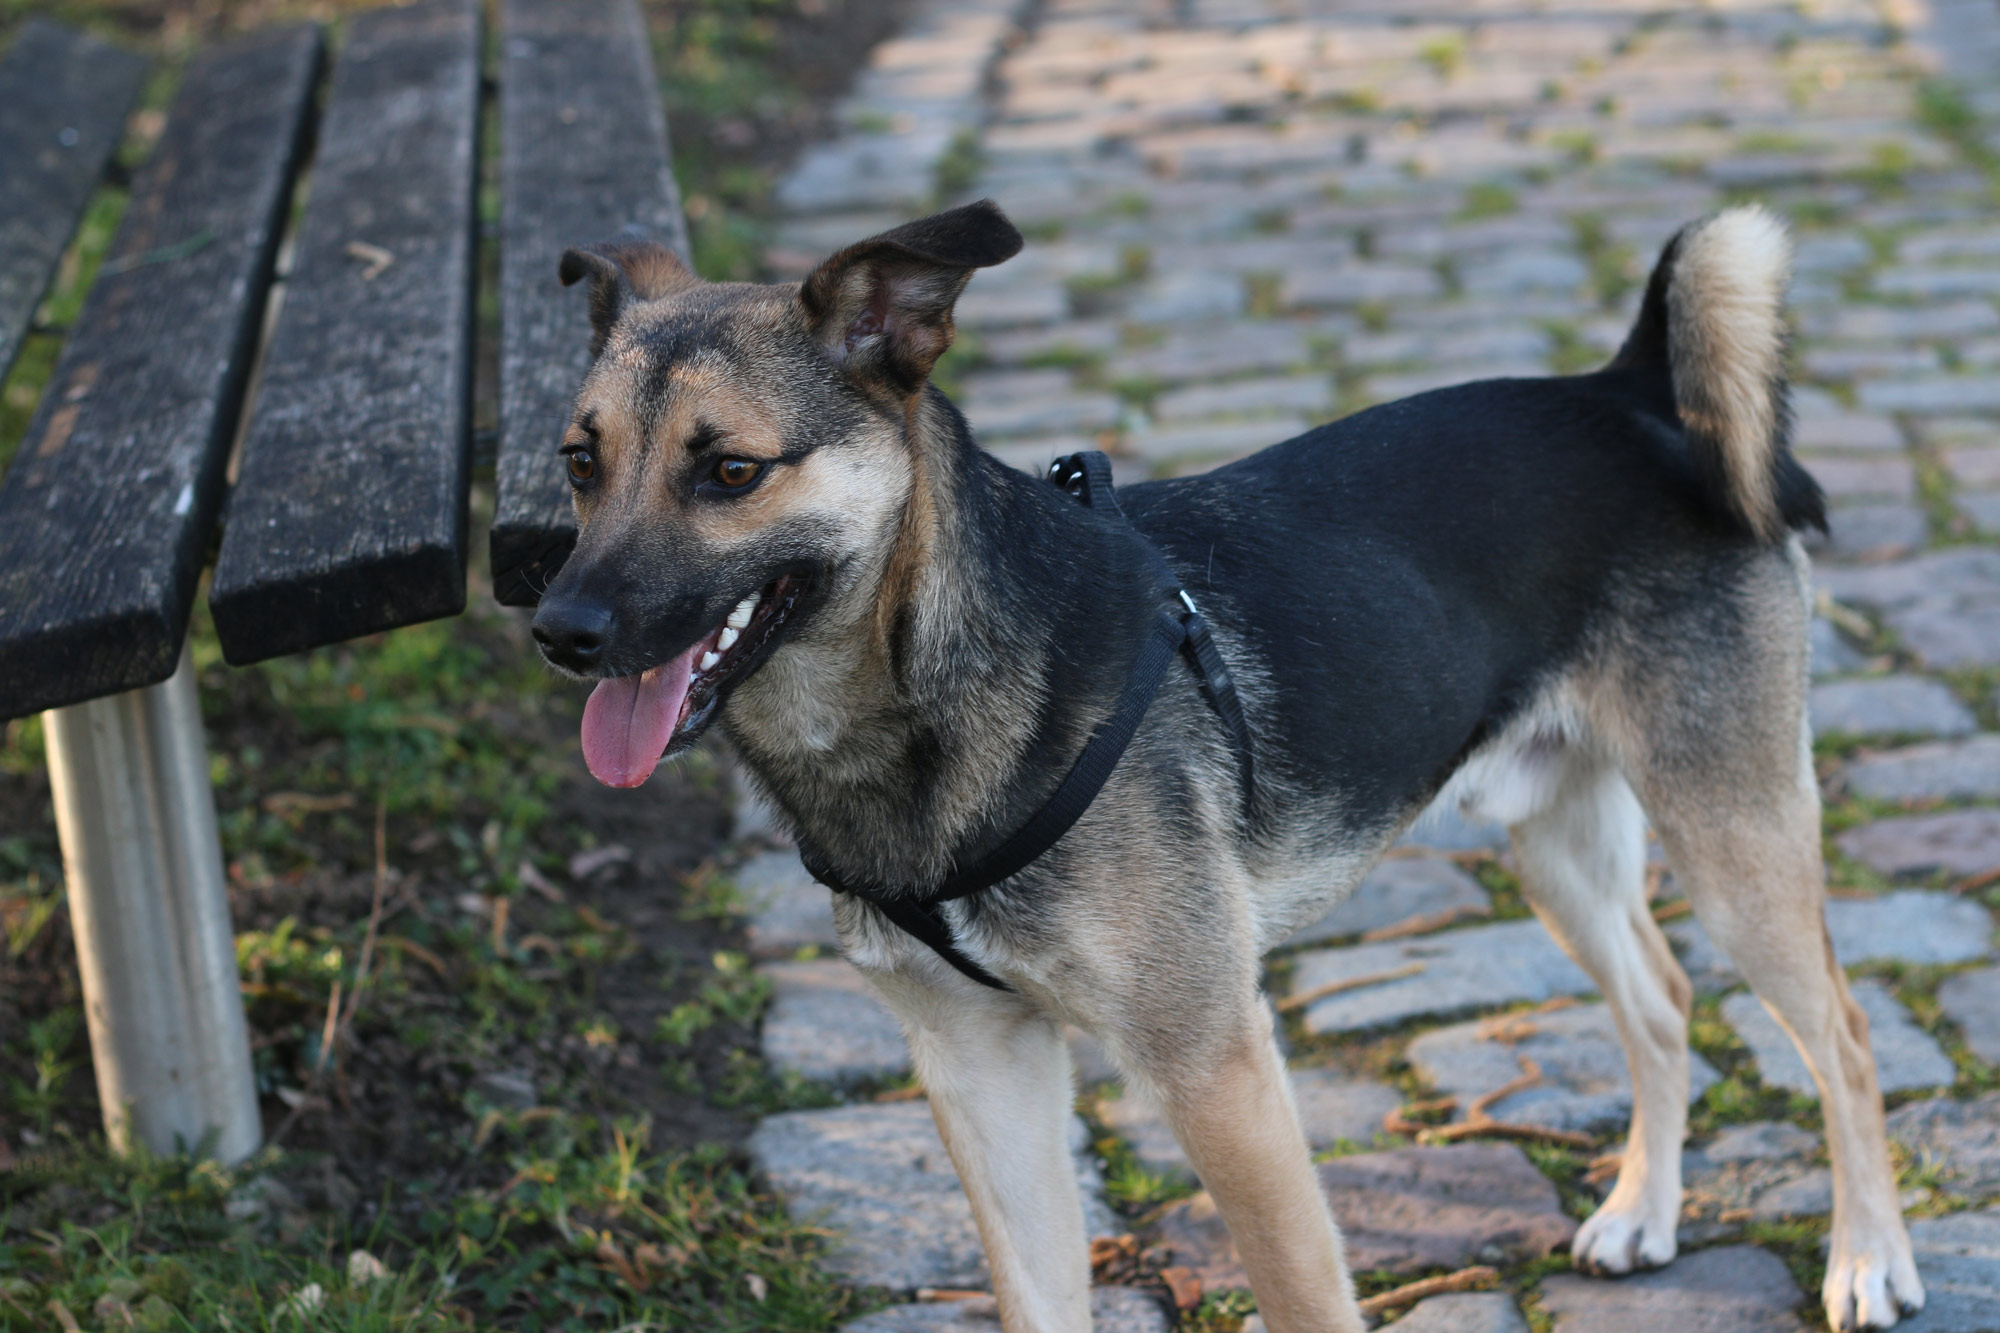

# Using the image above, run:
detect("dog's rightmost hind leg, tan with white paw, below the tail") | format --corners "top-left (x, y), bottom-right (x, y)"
top-left (1606, 546), bottom-right (1924, 1331)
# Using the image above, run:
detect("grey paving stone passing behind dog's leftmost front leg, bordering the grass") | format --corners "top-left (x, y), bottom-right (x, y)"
top-left (748, 1101), bottom-right (1116, 1291)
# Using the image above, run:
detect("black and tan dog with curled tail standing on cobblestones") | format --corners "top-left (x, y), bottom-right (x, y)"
top-left (534, 202), bottom-right (1924, 1333)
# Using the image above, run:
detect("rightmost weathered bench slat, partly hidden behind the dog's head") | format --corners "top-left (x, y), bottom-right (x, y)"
top-left (492, 0), bottom-right (688, 606)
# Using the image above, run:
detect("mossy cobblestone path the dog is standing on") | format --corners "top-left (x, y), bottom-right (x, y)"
top-left (738, 0), bottom-right (2000, 1333)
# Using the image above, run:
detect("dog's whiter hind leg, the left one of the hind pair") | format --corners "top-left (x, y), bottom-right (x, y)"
top-left (1512, 747), bottom-right (1692, 1273)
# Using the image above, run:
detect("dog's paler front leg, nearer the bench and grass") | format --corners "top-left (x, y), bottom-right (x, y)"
top-left (870, 967), bottom-right (1090, 1333)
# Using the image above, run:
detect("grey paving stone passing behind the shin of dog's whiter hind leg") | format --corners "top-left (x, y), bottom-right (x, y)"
top-left (1408, 1005), bottom-right (1718, 1133)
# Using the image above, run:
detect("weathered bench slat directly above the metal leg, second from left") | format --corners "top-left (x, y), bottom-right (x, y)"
top-left (0, 28), bottom-right (320, 717)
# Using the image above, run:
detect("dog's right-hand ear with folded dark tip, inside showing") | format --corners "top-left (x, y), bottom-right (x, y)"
top-left (798, 198), bottom-right (1020, 394)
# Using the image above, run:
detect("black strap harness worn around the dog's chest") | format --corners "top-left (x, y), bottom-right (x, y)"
top-left (798, 450), bottom-right (1254, 991)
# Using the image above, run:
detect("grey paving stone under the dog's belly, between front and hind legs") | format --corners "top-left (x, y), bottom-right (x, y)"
top-left (1292, 921), bottom-right (1596, 1035)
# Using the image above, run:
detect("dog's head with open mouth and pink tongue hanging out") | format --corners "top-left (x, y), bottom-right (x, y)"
top-left (534, 200), bottom-right (1022, 787)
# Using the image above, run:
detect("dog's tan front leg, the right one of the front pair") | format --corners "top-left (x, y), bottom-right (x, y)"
top-left (1142, 995), bottom-right (1368, 1333)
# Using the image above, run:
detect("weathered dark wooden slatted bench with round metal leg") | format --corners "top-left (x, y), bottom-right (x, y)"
top-left (0, 0), bottom-right (686, 1161)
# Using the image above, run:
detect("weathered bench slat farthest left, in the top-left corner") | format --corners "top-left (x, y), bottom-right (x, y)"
top-left (0, 18), bottom-right (146, 378)
